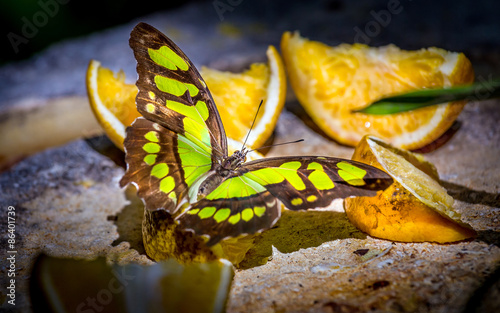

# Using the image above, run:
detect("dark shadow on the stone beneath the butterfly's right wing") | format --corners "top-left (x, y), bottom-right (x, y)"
top-left (238, 210), bottom-right (366, 269)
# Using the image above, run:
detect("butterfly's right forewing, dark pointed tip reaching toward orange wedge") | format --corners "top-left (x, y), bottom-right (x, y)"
top-left (241, 156), bottom-right (392, 210)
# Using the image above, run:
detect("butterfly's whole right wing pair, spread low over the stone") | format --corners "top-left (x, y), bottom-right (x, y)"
top-left (178, 157), bottom-right (392, 245)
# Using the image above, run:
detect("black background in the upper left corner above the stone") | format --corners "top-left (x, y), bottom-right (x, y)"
top-left (0, 0), bottom-right (195, 64)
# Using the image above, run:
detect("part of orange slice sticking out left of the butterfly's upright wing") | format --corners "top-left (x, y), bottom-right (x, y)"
top-left (86, 60), bottom-right (141, 150)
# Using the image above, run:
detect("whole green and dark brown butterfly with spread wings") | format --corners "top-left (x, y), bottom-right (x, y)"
top-left (120, 23), bottom-right (392, 246)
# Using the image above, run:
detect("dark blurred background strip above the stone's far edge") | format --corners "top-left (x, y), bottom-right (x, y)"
top-left (0, 0), bottom-right (500, 65)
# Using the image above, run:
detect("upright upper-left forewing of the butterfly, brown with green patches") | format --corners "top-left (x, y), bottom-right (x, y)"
top-left (129, 23), bottom-right (227, 161)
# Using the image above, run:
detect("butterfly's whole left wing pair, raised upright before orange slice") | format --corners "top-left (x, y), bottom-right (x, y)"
top-left (120, 23), bottom-right (227, 213)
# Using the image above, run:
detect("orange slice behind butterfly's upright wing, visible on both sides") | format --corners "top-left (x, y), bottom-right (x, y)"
top-left (87, 46), bottom-right (286, 150)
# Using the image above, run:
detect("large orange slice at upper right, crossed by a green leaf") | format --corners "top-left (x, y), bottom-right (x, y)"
top-left (281, 32), bottom-right (474, 149)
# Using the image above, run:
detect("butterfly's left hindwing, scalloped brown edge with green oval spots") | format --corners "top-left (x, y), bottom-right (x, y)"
top-left (120, 118), bottom-right (212, 214)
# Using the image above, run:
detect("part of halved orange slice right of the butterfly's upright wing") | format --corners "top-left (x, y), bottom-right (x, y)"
top-left (200, 46), bottom-right (286, 148)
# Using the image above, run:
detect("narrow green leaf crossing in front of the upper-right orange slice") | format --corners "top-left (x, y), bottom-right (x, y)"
top-left (353, 79), bottom-right (500, 115)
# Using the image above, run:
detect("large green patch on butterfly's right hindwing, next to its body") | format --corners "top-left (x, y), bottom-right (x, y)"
top-left (206, 175), bottom-right (266, 200)
